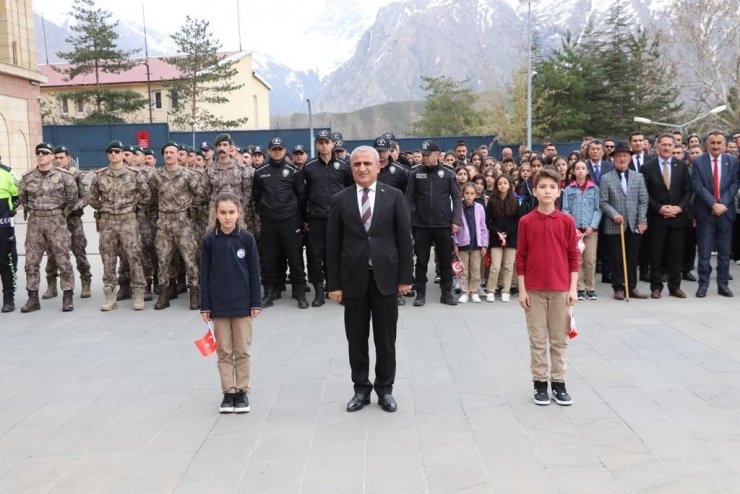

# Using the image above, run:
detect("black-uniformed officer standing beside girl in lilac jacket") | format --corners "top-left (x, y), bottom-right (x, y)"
top-left (406, 141), bottom-right (462, 307)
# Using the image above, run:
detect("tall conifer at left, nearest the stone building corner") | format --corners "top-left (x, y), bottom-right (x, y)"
top-left (57, 0), bottom-right (147, 123)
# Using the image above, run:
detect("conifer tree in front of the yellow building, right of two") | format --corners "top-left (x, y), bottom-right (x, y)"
top-left (165, 16), bottom-right (247, 129)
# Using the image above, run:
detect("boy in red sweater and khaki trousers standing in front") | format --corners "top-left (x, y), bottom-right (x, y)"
top-left (516, 167), bottom-right (579, 405)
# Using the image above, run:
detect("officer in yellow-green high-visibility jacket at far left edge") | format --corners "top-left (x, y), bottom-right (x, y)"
top-left (0, 152), bottom-right (20, 312)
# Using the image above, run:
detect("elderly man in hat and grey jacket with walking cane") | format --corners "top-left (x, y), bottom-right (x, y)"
top-left (599, 142), bottom-right (648, 300)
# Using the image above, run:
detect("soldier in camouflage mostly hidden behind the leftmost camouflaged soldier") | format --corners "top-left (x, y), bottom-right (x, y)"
top-left (41, 146), bottom-right (92, 299)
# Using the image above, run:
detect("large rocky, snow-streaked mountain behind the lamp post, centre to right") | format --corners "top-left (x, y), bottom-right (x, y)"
top-left (318, 0), bottom-right (670, 111)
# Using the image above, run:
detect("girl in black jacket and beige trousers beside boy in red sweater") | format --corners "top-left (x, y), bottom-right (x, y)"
top-left (486, 175), bottom-right (522, 302)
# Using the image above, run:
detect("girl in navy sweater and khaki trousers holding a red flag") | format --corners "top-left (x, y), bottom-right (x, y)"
top-left (200, 192), bottom-right (262, 413)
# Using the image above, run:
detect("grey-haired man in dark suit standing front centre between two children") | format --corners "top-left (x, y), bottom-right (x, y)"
top-left (326, 146), bottom-right (413, 412)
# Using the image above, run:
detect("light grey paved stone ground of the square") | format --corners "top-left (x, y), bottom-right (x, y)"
top-left (0, 218), bottom-right (740, 494)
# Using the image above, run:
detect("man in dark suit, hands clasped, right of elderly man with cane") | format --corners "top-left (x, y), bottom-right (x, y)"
top-left (640, 133), bottom-right (691, 298)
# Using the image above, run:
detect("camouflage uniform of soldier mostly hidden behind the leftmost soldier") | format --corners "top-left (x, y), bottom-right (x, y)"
top-left (46, 167), bottom-right (92, 285)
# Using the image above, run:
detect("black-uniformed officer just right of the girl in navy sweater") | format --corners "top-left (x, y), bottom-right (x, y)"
top-left (252, 137), bottom-right (308, 309)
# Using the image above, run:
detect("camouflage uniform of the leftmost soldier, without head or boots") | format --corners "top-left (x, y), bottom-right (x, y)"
top-left (20, 167), bottom-right (79, 291)
